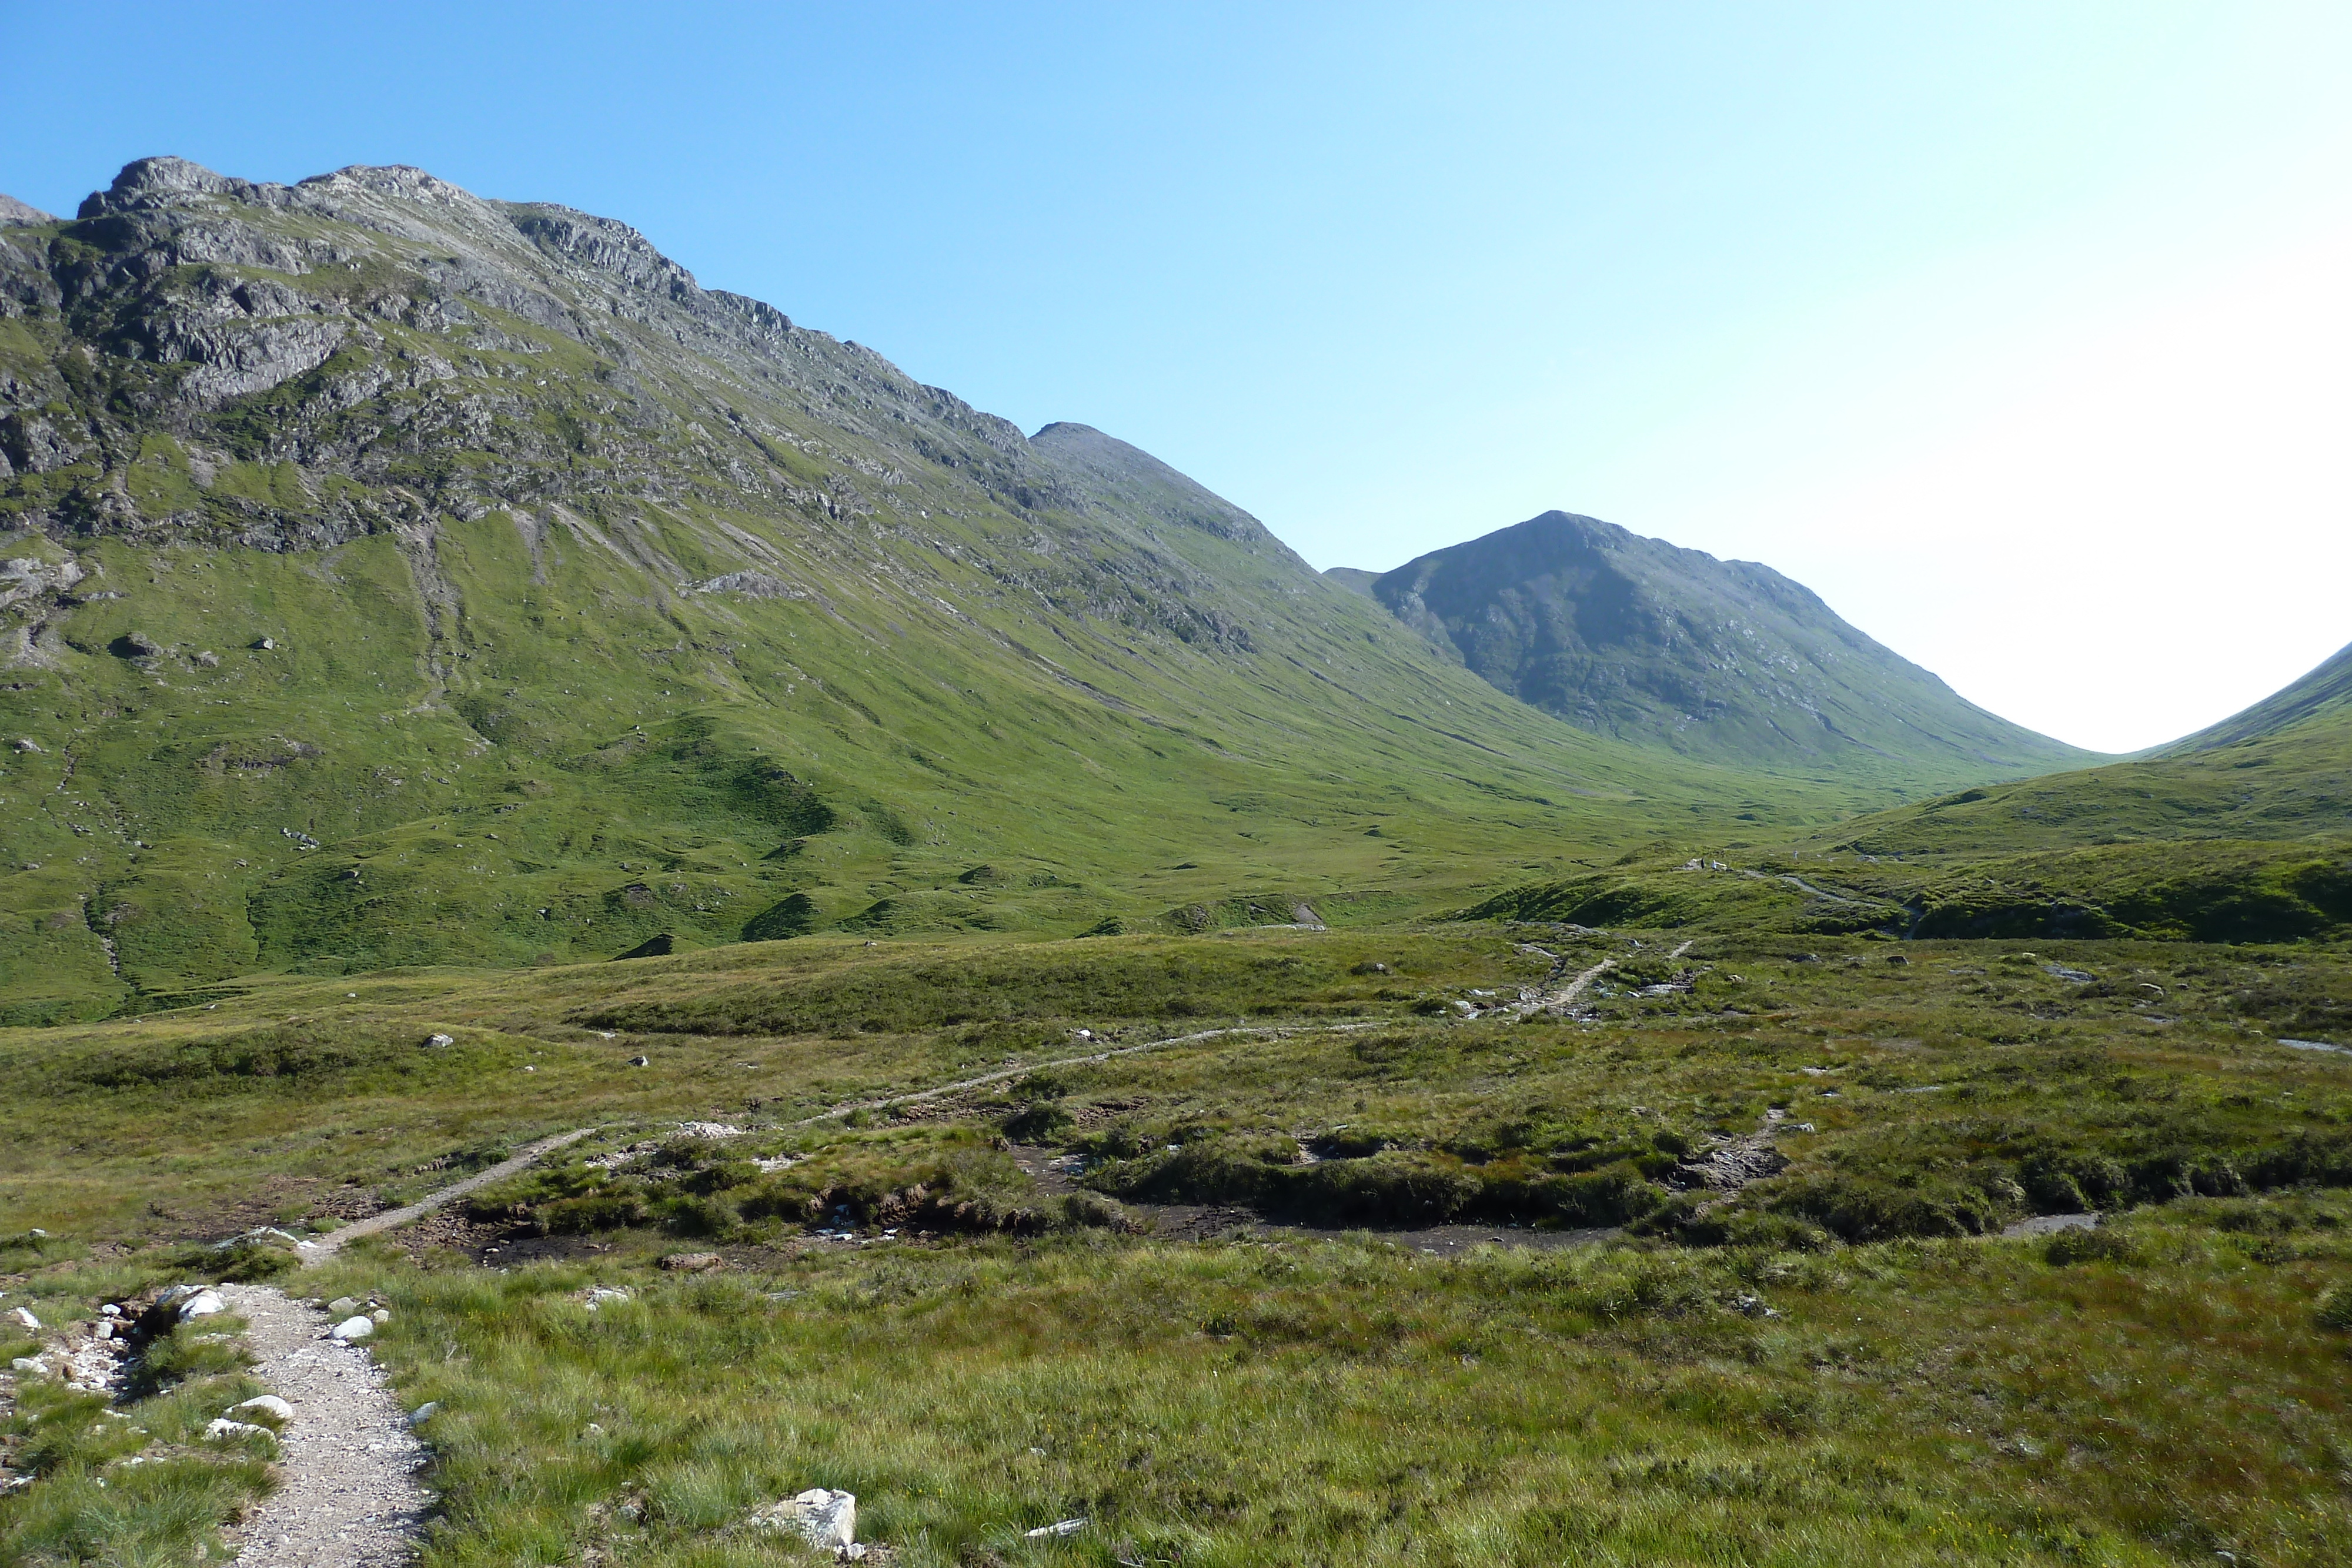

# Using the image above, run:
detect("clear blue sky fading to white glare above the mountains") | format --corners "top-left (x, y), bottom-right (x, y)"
top-left (0, 0), bottom-right (2352, 750)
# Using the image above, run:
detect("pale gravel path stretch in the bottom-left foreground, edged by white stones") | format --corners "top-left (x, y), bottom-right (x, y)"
top-left (221, 1286), bottom-right (430, 1568)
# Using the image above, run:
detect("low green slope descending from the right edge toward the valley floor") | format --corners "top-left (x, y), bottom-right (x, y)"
top-left (1477, 677), bottom-right (2352, 942)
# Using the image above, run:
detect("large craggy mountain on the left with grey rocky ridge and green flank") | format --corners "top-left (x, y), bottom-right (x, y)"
top-left (0, 158), bottom-right (1886, 1018)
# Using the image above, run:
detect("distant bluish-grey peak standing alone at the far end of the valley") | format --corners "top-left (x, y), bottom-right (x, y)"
top-left (1355, 513), bottom-right (2096, 792)
